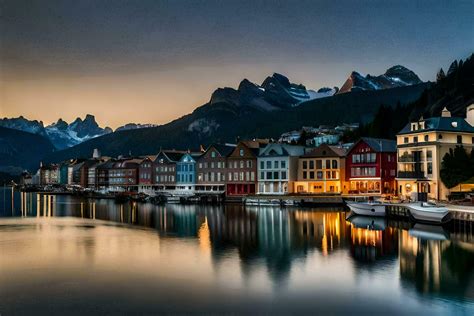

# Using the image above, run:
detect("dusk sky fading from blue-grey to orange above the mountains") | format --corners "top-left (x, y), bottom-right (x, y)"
top-left (0, 0), bottom-right (474, 128)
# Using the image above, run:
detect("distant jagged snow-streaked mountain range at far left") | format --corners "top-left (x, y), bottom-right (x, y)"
top-left (0, 114), bottom-right (112, 150)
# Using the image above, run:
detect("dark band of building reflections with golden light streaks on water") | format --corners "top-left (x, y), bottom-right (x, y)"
top-left (4, 191), bottom-right (474, 300)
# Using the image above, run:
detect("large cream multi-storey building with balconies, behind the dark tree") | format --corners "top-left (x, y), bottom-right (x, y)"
top-left (397, 105), bottom-right (474, 200)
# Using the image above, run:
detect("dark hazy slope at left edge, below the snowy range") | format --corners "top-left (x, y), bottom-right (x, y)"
top-left (0, 127), bottom-right (54, 174)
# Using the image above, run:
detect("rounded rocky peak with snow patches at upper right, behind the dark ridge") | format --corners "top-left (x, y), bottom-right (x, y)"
top-left (338, 65), bottom-right (422, 94)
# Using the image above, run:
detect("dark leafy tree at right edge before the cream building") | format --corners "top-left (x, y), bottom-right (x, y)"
top-left (440, 146), bottom-right (472, 189)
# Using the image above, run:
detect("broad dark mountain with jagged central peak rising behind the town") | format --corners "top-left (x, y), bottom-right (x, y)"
top-left (48, 79), bottom-right (429, 161)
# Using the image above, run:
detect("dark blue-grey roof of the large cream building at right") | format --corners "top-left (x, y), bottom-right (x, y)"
top-left (398, 117), bottom-right (474, 135)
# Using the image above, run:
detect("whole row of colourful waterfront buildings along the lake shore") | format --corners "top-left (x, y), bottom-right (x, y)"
top-left (33, 105), bottom-right (474, 200)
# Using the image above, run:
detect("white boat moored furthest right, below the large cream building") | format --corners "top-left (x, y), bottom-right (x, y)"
top-left (405, 202), bottom-right (452, 224)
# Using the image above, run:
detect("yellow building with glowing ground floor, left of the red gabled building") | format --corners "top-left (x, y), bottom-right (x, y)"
top-left (294, 144), bottom-right (346, 194)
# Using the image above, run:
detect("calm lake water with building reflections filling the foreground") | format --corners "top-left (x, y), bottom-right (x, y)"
top-left (0, 189), bottom-right (474, 316)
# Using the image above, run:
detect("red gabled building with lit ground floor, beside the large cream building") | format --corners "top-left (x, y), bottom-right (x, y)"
top-left (346, 137), bottom-right (397, 194)
